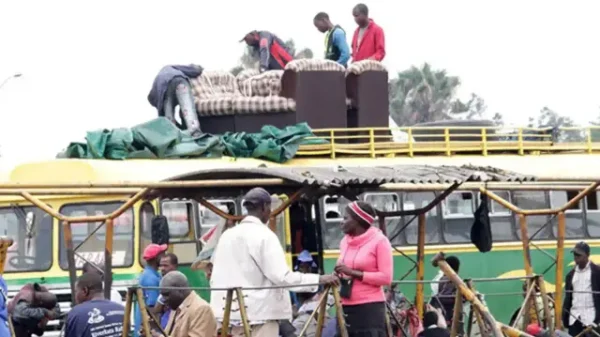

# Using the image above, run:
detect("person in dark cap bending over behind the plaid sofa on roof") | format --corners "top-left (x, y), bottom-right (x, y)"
top-left (240, 30), bottom-right (294, 73)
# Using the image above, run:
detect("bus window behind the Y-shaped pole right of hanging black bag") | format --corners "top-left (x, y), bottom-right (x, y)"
top-left (512, 191), bottom-right (550, 240)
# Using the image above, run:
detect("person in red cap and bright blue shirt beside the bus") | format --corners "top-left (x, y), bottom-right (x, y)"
top-left (133, 243), bottom-right (168, 337)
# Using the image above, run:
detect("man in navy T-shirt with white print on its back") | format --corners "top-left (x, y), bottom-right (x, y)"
top-left (65, 273), bottom-right (125, 337)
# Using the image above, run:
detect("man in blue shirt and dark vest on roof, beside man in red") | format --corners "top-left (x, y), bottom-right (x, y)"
top-left (313, 12), bottom-right (350, 67)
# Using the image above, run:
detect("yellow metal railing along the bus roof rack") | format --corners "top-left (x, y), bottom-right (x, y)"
top-left (297, 126), bottom-right (600, 158)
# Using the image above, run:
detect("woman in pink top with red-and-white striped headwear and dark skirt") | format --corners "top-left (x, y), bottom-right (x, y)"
top-left (335, 201), bottom-right (393, 337)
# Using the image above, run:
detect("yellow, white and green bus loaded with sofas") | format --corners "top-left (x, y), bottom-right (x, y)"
top-left (0, 140), bottom-right (600, 336)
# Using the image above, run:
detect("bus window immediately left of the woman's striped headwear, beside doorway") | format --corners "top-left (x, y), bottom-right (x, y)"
top-left (319, 195), bottom-right (350, 249)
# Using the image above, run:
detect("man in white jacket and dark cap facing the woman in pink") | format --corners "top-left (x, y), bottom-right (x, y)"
top-left (210, 188), bottom-right (339, 337)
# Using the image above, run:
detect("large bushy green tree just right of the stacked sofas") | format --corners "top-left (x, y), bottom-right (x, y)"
top-left (389, 63), bottom-right (487, 126)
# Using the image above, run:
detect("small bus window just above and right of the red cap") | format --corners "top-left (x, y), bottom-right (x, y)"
top-left (161, 200), bottom-right (194, 241)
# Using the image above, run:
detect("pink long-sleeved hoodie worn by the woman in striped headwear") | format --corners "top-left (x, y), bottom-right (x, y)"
top-left (338, 227), bottom-right (394, 305)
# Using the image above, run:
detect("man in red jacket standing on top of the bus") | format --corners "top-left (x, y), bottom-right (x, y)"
top-left (352, 4), bottom-right (385, 62)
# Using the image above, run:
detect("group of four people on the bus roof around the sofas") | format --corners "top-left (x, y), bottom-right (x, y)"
top-left (148, 4), bottom-right (385, 137)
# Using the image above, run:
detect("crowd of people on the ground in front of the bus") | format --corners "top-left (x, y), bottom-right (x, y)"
top-left (0, 197), bottom-right (600, 337)
